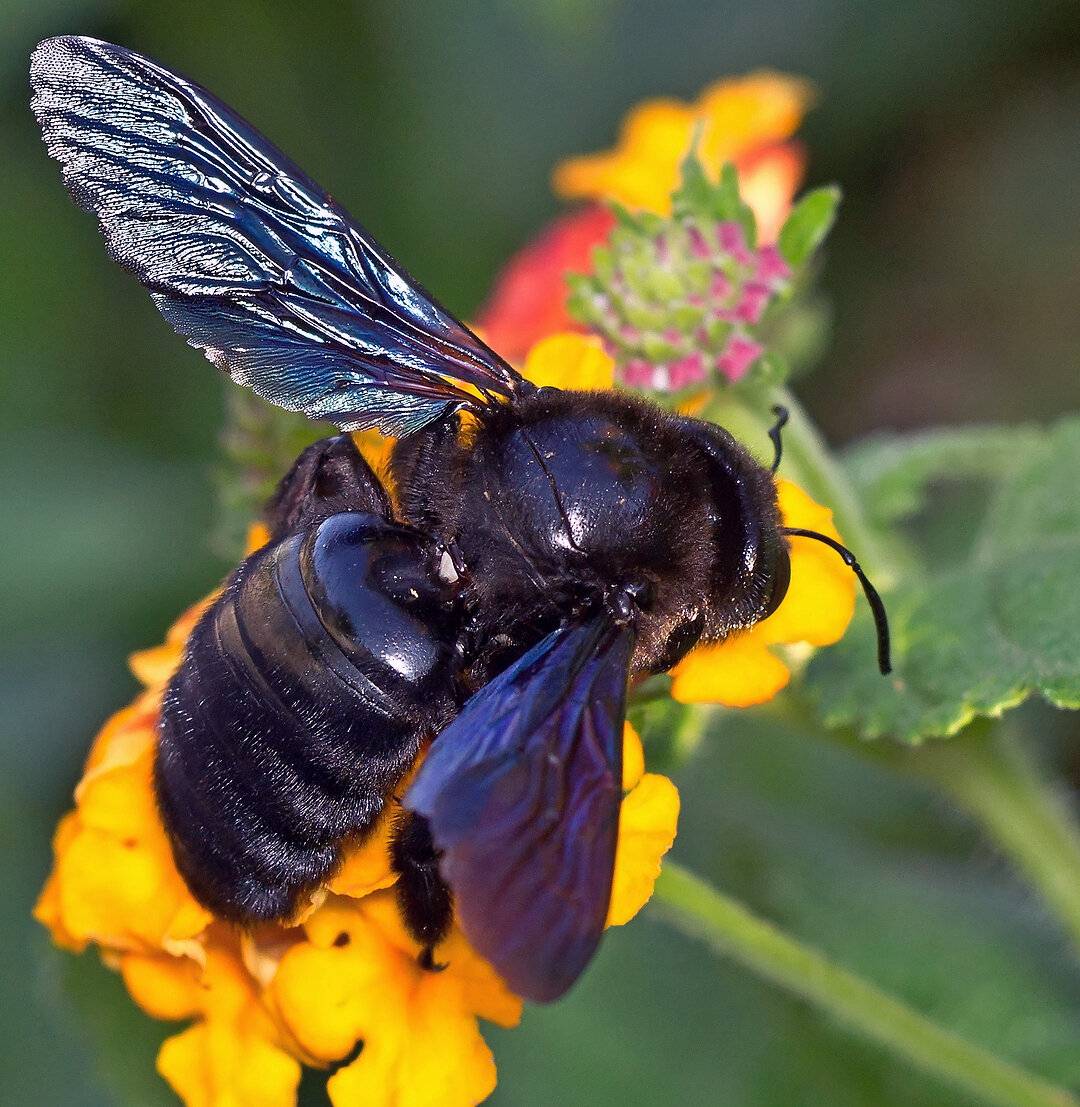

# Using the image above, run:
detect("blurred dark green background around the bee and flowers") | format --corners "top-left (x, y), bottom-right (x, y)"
top-left (6, 0), bottom-right (1080, 1107)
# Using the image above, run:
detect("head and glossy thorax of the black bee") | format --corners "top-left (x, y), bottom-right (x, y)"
top-left (485, 390), bottom-right (789, 672)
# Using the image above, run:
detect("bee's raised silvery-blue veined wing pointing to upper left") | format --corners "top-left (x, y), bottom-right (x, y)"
top-left (30, 37), bottom-right (522, 435)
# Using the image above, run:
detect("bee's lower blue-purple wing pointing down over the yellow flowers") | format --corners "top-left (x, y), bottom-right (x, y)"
top-left (405, 618), bottom-right (633, 1002)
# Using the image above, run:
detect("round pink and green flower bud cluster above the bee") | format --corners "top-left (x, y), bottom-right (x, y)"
top-left (571, 218), bottom-right (792, 392)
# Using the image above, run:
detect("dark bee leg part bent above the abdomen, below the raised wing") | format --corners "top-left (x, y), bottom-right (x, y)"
top-left (262, 434), bottom-right (391, 538)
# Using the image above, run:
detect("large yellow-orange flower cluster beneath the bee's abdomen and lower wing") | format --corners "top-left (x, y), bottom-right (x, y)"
top-left (34, 518), bottom-right (678, 1107)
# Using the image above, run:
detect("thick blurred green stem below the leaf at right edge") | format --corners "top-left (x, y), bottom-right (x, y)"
top-left (906, 721), bottom-right (1080, 950)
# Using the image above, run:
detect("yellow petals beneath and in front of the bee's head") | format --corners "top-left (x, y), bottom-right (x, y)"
top-left (672, 480), bottom-right (855, 707)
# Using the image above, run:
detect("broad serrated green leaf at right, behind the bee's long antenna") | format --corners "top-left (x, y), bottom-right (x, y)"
top-left (807, 420), bottom-right (1080, 742)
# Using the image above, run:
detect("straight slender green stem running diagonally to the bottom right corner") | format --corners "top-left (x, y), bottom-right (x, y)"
top-left (655, 861), bottom-right (1078, 1107)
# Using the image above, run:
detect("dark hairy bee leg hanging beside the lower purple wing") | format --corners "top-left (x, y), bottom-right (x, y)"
top-left (391, 811), bottom-right (454, 972)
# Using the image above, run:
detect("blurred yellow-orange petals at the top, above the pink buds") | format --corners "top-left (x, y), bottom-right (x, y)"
top-left (553, 71), bottom-right (812, 242)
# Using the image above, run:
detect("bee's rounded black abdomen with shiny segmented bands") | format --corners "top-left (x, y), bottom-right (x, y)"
top-left (156, 514), bottom-right (455, 920)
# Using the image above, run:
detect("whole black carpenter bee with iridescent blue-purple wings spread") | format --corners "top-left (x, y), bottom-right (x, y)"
top-left (31, 38), bottom-right (889, 1001)
